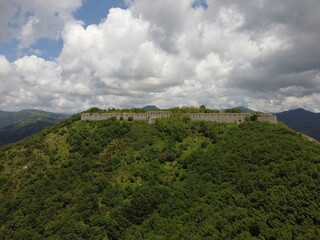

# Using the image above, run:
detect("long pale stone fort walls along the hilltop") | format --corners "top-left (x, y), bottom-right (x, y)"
top-left (81, 111), bottom-right (278, 124)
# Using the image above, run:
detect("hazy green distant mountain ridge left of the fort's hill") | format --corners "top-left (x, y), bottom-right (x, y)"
top-left (0, 110), bottom-right (68, 146)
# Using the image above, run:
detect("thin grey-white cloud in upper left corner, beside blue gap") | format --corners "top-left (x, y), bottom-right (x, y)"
top-left (0, 0), bottom-right (82, 48)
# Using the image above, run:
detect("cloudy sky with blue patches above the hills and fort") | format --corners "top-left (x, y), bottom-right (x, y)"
top-left (0, 0), bottom-right (320, 113)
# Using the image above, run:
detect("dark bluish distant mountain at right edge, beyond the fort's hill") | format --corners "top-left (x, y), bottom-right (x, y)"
top-left (276, 108), bottom-right (320, 141)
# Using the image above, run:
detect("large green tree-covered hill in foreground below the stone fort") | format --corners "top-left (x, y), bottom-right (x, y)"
top-left (0, 111), bottom-right (320, 240)
